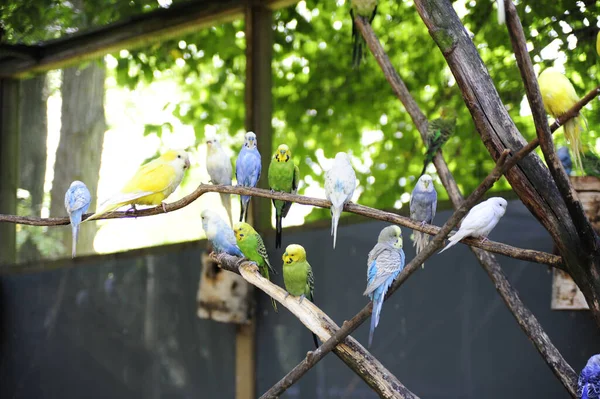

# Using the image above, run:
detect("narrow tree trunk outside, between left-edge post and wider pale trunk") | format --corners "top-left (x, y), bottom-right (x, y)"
top-left (18, 73), bottom-right (48, 262)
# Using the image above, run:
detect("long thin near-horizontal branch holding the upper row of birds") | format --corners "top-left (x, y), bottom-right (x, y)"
top-left (0, 184), bottom-right (563, 269)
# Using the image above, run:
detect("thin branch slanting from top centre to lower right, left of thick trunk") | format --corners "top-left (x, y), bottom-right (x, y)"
top-left (355, 11), bottom-right (576, 395)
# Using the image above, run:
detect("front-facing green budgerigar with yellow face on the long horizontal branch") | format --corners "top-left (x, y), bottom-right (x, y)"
top-left (268, 144), bottom-right (300, 248)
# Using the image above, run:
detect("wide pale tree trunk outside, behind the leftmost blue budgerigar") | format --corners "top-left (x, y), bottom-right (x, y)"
top-left (50, 62), bottom-right (106, 254)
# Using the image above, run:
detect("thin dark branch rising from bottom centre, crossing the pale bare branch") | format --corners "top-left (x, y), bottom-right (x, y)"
top-left (261, 150), bottom-right (509, 399)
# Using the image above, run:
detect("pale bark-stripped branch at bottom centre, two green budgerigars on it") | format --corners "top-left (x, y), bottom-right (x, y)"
top-left (211, 253), bottom-right (418, 399)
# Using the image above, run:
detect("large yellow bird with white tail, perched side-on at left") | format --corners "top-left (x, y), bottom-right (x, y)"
top-left (85, 150), bottom-right (190, 222)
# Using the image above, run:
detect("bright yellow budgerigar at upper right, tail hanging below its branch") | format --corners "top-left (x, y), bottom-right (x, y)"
top-left (538, 68), bottom-right (584, 170)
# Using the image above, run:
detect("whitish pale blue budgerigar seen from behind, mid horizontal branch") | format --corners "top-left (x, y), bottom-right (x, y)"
top-left (325, 152), bottom-right (356, 248)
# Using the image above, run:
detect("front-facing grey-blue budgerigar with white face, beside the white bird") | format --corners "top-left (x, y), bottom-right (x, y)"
top-left (410, 175), bottom-right (437, 267)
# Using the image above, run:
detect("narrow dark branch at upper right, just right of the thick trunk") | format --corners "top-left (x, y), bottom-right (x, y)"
top-left (504, 0), bottom-right (599, 254)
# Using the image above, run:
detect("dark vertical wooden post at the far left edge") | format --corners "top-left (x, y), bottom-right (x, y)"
top-left (0, 79), bottom-right (20, 264)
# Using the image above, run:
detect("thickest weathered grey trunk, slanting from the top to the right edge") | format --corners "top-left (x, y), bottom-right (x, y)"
top-left (415, 0), bottom-right (600, 332)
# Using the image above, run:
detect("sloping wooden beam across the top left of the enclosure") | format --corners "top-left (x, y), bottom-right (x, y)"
top-left (0, 0), bottom-right (297, 77)
